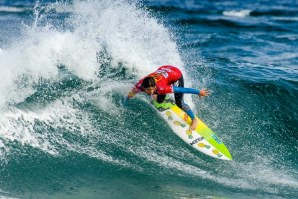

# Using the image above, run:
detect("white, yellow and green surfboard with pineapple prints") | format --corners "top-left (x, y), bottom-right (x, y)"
top-left (151, 98), bottom-right (232, 160)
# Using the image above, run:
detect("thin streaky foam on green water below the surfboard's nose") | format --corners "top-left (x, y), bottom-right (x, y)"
top-left (122, 130), bottom-right (298, 194)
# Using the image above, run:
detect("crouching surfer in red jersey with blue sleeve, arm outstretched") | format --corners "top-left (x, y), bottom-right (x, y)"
top-left (127, 65), bottom-right (210, 130)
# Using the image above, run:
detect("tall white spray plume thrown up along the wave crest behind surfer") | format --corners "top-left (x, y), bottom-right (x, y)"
top-left (0, 0), bottom-right (184, 109)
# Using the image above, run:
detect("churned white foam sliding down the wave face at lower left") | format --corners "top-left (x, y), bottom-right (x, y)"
top-left (0, 95), bottom-right (131, 167)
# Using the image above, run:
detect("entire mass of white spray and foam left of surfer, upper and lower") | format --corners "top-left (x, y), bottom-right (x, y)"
top-left (0, 1), bottom-right (184, 163)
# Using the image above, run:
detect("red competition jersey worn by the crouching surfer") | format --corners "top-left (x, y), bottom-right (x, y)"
top-left (132, 65), bottom-right (182, 95)
